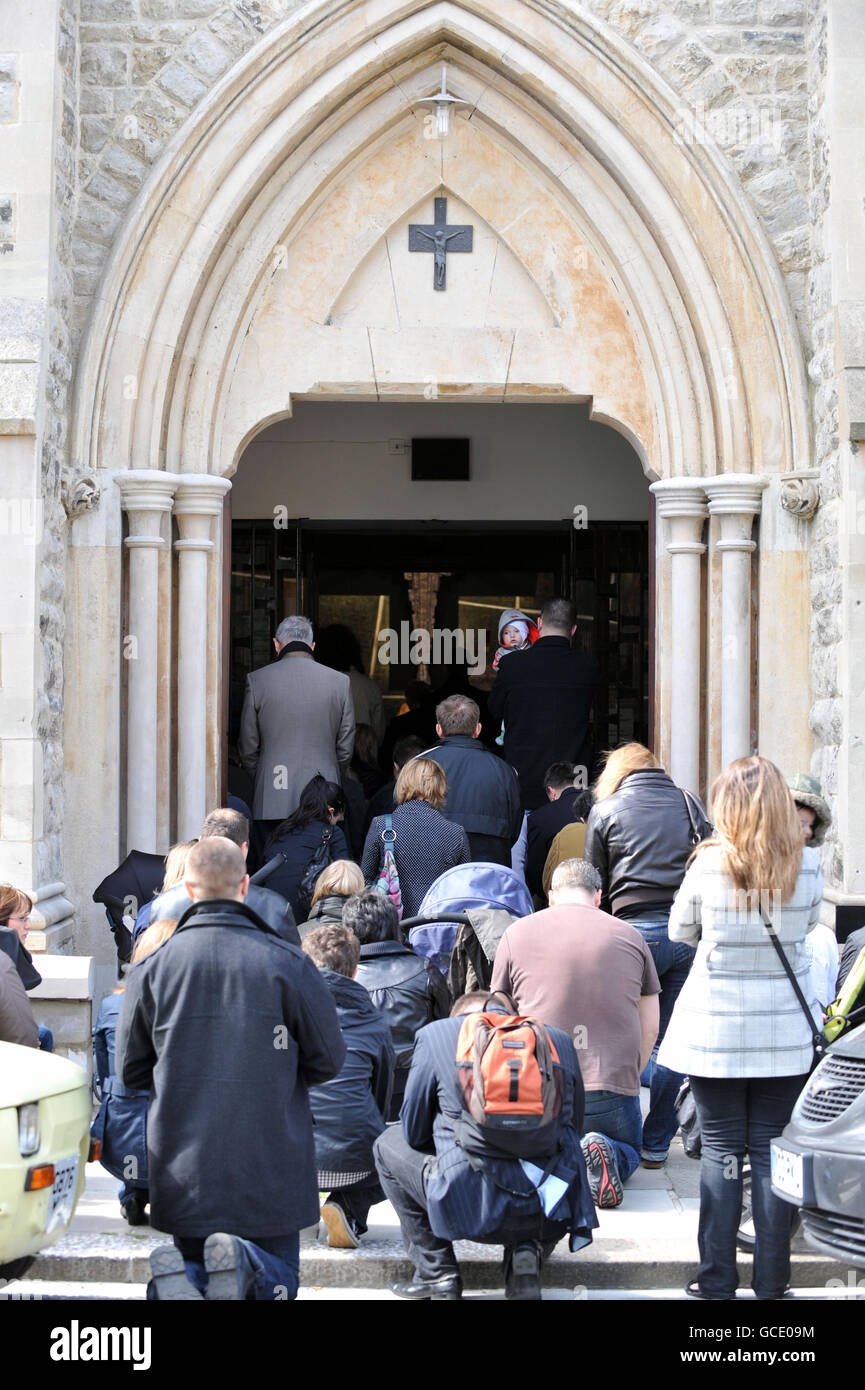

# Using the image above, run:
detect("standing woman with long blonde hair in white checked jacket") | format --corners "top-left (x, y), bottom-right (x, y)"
top-left (659, 756), bottom-right (823, 1298)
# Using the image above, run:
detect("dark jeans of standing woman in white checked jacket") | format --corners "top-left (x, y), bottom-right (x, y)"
top-left (691, 1076), bottom-right (808, 1298)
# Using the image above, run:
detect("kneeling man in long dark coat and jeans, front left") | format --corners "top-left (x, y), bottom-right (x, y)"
top-left (117, 837), bottom-right (345, 1300)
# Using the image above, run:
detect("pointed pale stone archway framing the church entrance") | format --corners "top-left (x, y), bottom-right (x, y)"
top-left (67, 0), bottom-right (809, 889)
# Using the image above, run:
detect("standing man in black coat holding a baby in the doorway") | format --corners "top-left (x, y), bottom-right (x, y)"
top-left (488, 599), bottom-right (599, 810)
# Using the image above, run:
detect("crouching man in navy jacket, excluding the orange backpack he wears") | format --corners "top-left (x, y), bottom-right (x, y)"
top-left (374, 994), bottom-right (598, 1300)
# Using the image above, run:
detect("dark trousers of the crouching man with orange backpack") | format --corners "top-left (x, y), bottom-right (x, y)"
top-left (373, 1125), bottom-right (556, 1280)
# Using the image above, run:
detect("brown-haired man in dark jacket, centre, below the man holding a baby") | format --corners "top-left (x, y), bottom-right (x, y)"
top-left (421, 695), bottom-right (523, 867)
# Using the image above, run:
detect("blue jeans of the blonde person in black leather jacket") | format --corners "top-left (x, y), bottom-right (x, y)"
top-left (626, 909), bottom-right (695, 1162)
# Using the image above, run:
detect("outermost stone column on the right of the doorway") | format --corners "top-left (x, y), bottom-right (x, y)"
top-left (704, 473), bottom-right (768, 767)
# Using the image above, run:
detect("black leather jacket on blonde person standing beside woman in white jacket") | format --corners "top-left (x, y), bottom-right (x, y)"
top-left (585, 767), bottom-right (712, 917)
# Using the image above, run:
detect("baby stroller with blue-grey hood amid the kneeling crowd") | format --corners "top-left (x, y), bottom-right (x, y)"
top-left (402, 863), bottom-right (533, 999)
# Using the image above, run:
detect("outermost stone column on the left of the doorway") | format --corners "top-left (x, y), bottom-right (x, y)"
top-left (117, 468), bottom-right (178, 853)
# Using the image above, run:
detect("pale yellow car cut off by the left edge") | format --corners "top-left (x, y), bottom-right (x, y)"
top-left (0, 1043), bottom-right (96, 1279)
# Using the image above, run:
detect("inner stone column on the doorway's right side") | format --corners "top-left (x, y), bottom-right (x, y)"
top-left (652, 478), bottom-right (708, 792)
